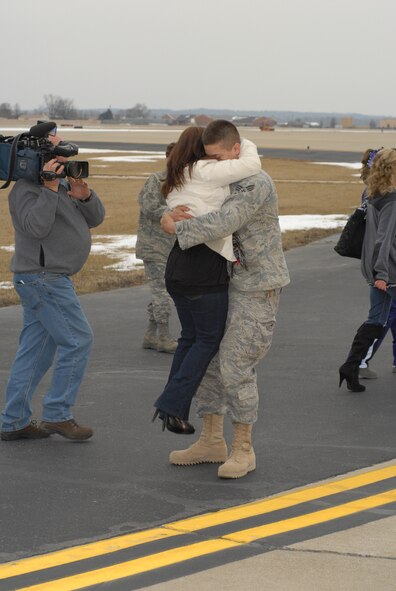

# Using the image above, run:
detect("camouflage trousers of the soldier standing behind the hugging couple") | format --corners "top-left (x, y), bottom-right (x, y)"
top-left (143, 261), bottom-right (172, 324)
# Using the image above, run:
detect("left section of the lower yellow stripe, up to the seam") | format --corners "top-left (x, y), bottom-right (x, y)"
top-left (15, 539), bottom-right (240, 591)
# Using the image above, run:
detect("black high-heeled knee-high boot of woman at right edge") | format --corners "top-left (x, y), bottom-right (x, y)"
top-left (339, 322), bottom-right (384, 392)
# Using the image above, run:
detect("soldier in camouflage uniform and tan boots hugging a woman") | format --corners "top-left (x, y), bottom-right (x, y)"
top-left (162, 122), bottom-right (289, 478)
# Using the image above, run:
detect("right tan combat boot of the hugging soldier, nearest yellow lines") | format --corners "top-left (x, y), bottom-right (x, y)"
top-left (218, 423), bottom-right (256, 478)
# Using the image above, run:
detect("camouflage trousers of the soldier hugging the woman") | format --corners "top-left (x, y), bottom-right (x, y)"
top-left (196, 286), bottom-right (281, 424)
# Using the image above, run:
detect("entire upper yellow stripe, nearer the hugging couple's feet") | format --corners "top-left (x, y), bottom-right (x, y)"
top-left (0, 465), bottom-right (396, 580)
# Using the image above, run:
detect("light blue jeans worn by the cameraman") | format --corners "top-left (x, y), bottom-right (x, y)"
top-left (1, 273), bottom-right (93, 431)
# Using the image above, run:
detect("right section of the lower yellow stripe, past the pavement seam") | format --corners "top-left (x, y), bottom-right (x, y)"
top-left (224, 489), bottom-right (396, 544)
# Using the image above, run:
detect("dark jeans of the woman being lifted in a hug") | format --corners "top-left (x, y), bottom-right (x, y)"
top-left (154, 291), bottom-right (228, 420)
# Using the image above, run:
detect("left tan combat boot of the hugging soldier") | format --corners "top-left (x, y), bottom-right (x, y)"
top-left (169, 415), bottom-right (227, 466)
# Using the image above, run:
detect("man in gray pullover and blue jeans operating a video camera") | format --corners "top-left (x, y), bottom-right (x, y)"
top-left (1, 135), bottom-right (105, 441)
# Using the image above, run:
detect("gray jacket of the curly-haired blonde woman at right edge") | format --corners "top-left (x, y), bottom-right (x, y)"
top-left (361, 191), bottom-right (396, 284)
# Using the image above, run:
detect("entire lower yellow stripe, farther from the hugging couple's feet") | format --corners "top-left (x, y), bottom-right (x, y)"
top-left (15, 489), bottom-right (396, 591)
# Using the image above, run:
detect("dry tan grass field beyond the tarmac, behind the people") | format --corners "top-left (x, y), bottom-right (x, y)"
top-left (0, 153), bottom-right (362, 306)
